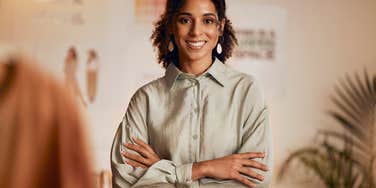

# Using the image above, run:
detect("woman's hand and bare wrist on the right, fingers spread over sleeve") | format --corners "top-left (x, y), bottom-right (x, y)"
top-left (192, 152), bottom-right (268, 187)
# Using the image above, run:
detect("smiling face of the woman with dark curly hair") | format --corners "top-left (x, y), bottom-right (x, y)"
top-left (172, 0), bottom-right (224, 61)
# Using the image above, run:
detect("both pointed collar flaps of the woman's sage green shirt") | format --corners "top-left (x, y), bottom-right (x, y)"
top-left (165, 58), bottom-right (226, 89)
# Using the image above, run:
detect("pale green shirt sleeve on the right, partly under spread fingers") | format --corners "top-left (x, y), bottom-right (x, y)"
top-left (202, 81), bottom-right (273, 188)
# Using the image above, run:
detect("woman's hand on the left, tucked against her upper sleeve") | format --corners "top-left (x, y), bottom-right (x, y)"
top-left (122, 138), bottom-right (161, 168)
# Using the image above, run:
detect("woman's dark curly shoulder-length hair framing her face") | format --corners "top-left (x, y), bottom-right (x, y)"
top-left (150, 0), bottom-right (238, 68)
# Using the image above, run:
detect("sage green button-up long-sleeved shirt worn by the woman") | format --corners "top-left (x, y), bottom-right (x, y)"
top-left (111, 60), bottom-right (272, 188)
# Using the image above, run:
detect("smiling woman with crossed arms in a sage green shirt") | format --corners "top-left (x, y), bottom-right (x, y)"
top-left (111, 0), bottom-right (272, 187)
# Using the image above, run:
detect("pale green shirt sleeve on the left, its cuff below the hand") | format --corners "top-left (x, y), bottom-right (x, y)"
top-left (111, 92), bottom-right (192, 188)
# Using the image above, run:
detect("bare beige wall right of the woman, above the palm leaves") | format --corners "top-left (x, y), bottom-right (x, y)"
top-left (252, 0), bottom-right (376, 187)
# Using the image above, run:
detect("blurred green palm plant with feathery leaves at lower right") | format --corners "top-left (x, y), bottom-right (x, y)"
top-left (278, 71), bottom-right (376, 188)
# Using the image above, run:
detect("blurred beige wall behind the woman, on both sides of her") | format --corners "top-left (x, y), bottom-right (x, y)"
top-left (0, 0), bottom-right (376, 187)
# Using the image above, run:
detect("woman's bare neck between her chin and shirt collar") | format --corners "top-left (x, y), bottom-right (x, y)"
top-left (179, 57), bottom-right (213, 76)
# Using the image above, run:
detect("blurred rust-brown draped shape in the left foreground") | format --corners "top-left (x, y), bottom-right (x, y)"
top-left (0, 56), bottom-right (94, 188)
